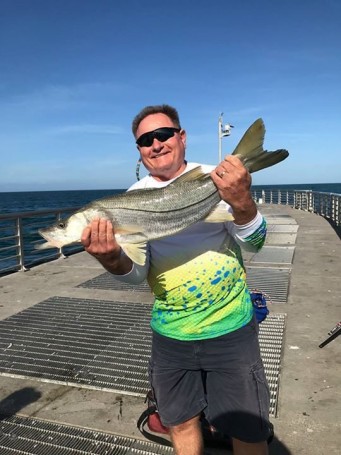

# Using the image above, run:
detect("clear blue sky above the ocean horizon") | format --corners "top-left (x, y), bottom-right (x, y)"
top-left (0, 0), bottom-right (341, 191)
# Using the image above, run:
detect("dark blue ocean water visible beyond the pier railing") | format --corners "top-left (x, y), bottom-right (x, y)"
top-left (0, 183), bottom-right (341, 275)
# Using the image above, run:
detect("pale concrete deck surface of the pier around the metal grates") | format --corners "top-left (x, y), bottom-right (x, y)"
top-left (0, 205), bottom-right (341, 455)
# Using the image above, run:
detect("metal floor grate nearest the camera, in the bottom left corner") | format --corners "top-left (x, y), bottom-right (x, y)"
top-left (0, 416), bottom-right (173, 455)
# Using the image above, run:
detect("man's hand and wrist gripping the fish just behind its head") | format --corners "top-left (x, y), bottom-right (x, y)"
top-left (81, 218), bottom-right (132, 275)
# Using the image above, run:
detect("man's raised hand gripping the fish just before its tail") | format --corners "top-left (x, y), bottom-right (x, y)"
top-left (211, 155), bottom-right (257, 225)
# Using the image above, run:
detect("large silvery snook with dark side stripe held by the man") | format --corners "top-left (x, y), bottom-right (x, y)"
top-left (36, 119), bottom-right (289, 265)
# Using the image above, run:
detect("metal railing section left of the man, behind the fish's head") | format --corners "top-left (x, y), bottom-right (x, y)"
top-left (0, 207), bottom-right (82, 275)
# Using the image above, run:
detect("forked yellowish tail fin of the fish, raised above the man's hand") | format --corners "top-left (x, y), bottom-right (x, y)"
top-left (232, 118), bottom-right (289, 173)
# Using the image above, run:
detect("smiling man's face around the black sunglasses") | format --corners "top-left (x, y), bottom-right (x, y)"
top-left (136, 113), bottom-right (186, 181)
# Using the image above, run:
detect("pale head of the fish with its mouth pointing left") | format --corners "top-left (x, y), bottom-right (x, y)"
top-left (36, 212), bottom-right (88, 250)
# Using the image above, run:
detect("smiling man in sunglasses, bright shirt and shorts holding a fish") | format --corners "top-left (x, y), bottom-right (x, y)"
top-left (82, 105), bottom-right (269, 455)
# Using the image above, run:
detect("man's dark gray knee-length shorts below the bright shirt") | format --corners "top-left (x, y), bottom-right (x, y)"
top-left (149, 320), bottom-right (270, 442)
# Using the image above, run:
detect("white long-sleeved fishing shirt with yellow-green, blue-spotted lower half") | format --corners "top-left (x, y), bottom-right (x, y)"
top-left (117, 163), bottom-right (266, 340)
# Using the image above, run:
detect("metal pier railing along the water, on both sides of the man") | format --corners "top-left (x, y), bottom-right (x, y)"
top-left (0, 189), bottom-right (341, 275)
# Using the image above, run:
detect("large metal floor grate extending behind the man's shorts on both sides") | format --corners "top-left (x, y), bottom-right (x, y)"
top-left (0, 297), bottom-right (284, 414)
